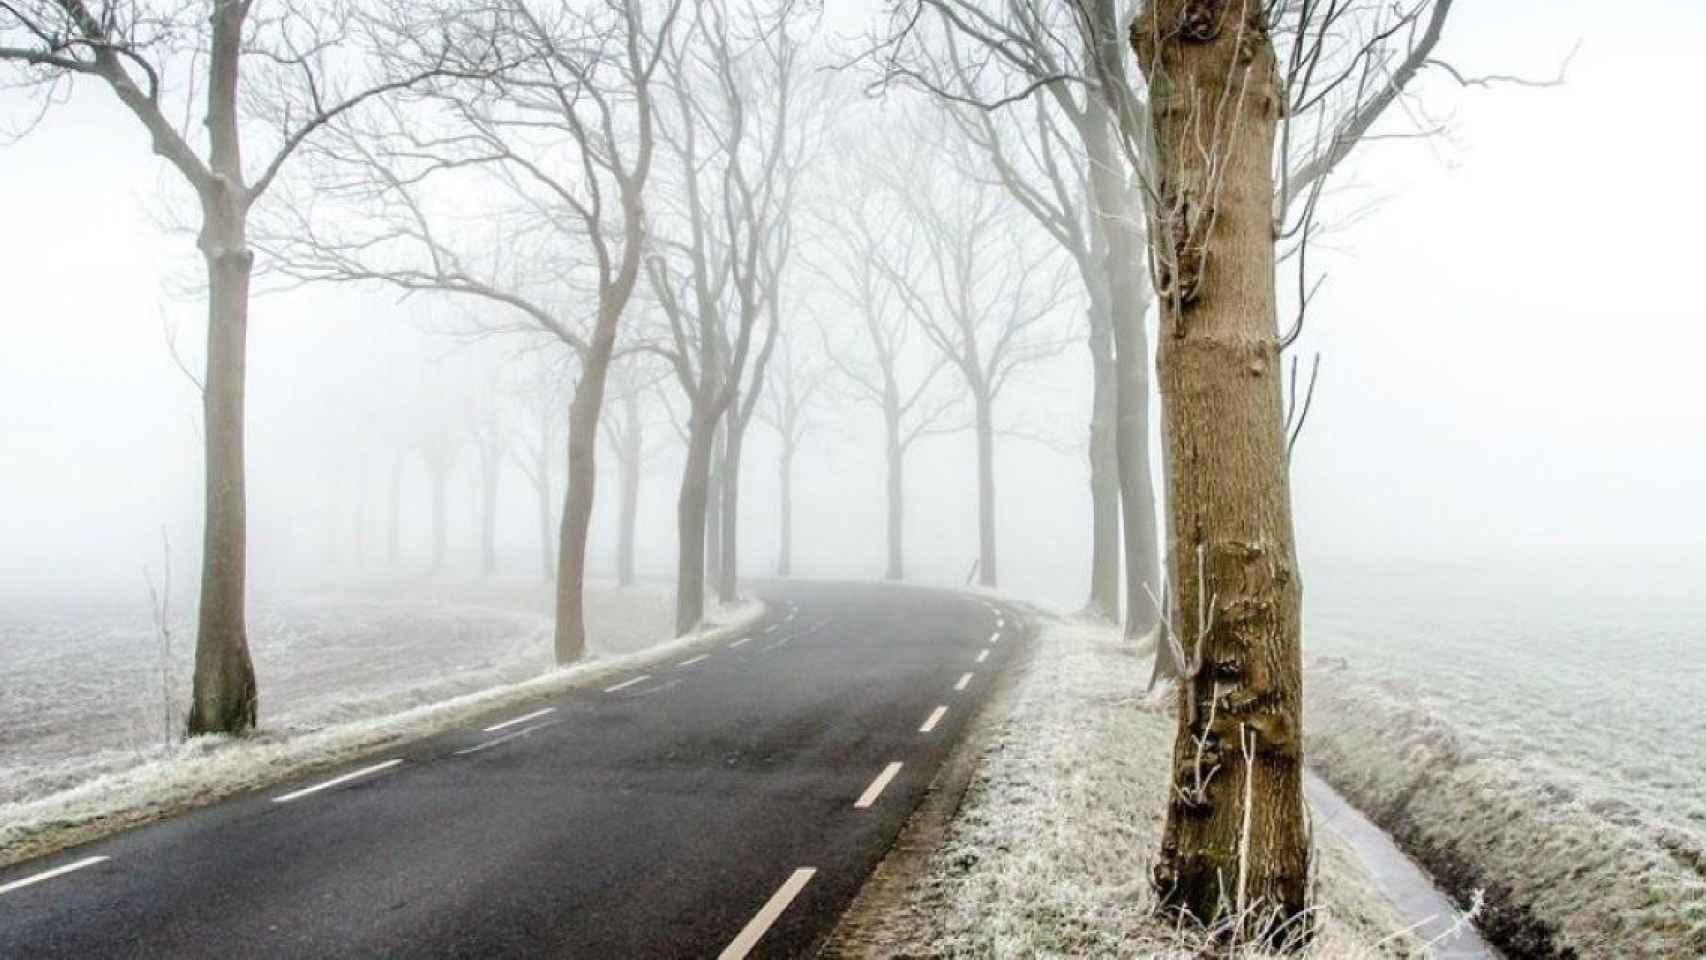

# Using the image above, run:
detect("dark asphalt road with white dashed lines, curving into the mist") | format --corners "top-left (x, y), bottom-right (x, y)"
top-left (0, 583), bottom-right (1025, 960)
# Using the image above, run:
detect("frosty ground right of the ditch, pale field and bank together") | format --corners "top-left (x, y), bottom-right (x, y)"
top-left (1305, 561), bottom-right (1706, 957)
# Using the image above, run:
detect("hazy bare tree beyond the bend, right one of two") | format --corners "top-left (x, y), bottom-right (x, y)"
top-left (879, 123), bottom-right (1068, 587)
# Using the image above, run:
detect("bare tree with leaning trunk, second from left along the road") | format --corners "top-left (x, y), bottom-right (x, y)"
top-left (270, 0), bottom-right (682, 663)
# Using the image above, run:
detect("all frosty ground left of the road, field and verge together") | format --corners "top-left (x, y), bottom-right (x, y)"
top-left (0, 569), bottom-right (763, 861)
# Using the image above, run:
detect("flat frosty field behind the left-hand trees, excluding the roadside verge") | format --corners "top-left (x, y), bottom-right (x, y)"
top-left (0, 580), bottom-right (674, 803)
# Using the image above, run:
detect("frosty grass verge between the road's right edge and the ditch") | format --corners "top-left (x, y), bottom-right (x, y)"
top-left (855, 622), bottom-right (1416, 958)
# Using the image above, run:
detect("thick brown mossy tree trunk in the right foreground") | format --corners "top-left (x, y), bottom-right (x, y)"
top-left (1128, 0), bottom-right (1310, 936)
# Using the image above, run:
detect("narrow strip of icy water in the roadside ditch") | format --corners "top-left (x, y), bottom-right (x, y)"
top-left (1303, 772), bottom-right (1503, 960)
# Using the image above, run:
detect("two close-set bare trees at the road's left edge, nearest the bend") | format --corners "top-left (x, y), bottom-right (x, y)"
top-left (650, 0), bottom-right (804, 633)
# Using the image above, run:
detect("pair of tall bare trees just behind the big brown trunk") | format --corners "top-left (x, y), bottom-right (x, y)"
top-left (867, 0), bottom-right (1160, 636)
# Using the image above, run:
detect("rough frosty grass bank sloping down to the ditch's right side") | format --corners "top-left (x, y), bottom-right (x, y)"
top-left (1305, 660), bottom-right (1706, 958)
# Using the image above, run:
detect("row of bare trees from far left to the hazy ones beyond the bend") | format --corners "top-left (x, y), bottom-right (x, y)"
top-left (0, 0), bottom-right (1085, 733)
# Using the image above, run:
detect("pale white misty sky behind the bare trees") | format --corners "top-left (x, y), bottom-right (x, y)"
top-left (0, 0), bottom-right (1706, 602)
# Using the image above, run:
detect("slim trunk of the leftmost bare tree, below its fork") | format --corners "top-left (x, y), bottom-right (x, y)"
top-left (188, 215), bottom-right (258, 735)
